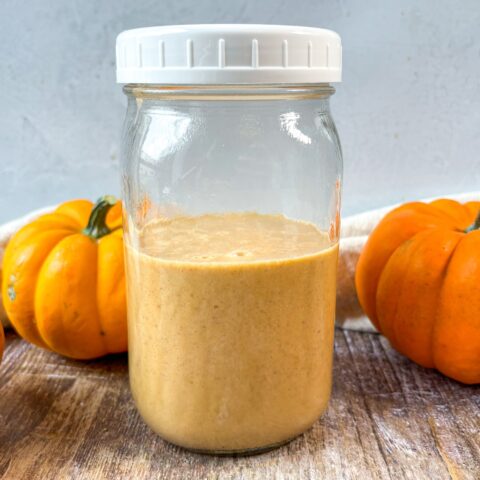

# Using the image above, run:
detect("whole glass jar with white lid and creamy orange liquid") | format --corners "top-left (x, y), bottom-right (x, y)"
top-left (117, 25), bottom-right (342, 453)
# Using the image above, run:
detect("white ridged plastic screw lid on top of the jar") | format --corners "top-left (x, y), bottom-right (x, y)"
top-left (117, 24), bottom-right (342, 85)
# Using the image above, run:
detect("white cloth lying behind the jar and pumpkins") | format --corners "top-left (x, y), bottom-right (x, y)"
top-left (0, 192), bottom-right (480, 331)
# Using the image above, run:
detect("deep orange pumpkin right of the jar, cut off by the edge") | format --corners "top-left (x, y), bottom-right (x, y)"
top-left (355, 199), bottom-right (480, 384)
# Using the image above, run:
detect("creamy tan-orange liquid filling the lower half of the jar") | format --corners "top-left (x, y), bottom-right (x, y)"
top-left (126, 213), bottom-right (338, 452)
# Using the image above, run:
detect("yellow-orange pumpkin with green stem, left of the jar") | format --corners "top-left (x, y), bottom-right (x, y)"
top-left (2, 196), bottom-right (127, 359)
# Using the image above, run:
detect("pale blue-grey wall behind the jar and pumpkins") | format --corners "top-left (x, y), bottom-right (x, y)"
top-left (0, 0), bottom-right (480, 221)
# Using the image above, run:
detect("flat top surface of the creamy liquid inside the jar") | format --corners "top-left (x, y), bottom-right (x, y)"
top-left (140, 213), bottom-right (331, 263)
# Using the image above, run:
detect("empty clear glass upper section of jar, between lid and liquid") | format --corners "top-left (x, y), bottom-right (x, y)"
top-left (122, 85), bottom-right (342, 241)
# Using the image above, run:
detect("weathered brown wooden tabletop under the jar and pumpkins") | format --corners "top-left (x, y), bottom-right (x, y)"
top-left (0, 330), bottom-right (480, 480)
